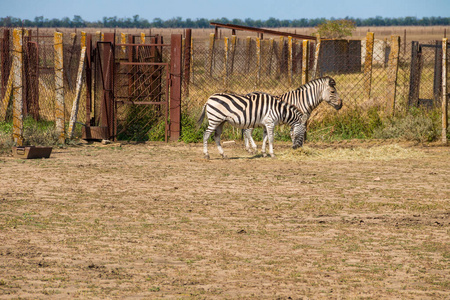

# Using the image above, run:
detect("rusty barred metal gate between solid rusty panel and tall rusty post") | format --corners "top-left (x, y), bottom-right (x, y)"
top-left (114, 36), bottom-right (170, 141)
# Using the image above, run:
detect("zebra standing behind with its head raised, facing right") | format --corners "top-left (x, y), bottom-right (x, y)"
top-left (243, 76), bottom-right (342, 153)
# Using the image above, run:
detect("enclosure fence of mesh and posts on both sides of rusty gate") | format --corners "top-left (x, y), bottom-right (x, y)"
top-left (0, 28), bottom-right (448, 147)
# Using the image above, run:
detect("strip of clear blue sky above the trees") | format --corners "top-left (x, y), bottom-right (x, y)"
top-left (0, 0), bottom-right (450, 21)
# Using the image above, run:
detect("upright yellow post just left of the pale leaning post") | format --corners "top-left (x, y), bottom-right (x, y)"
top-left (54, 32), bottom-right (65, 144)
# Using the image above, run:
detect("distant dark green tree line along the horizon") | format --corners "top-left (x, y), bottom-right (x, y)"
top-left (0, 15), bottom-right (450, 28)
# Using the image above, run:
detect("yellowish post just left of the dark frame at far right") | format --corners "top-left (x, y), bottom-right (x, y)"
top-left (386, 35), bottom-right (400, 115)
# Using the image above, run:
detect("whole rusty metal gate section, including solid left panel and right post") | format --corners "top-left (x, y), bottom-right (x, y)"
top-left (83, 33), bottom-right (181, 141)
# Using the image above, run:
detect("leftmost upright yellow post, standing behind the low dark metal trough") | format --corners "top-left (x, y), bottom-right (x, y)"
top-left (11, 29), bottom-right (23, 147)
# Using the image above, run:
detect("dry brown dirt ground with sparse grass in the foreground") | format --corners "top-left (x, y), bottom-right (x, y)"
top-left (0, 141), bottom-right (450, 299)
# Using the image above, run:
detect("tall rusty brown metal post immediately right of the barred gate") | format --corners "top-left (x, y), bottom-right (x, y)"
top-left (170, 34), bottom-right (182, 141)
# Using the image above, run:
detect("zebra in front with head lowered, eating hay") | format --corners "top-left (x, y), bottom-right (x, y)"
top-left (197, 93), bottom-right (306, 159)
